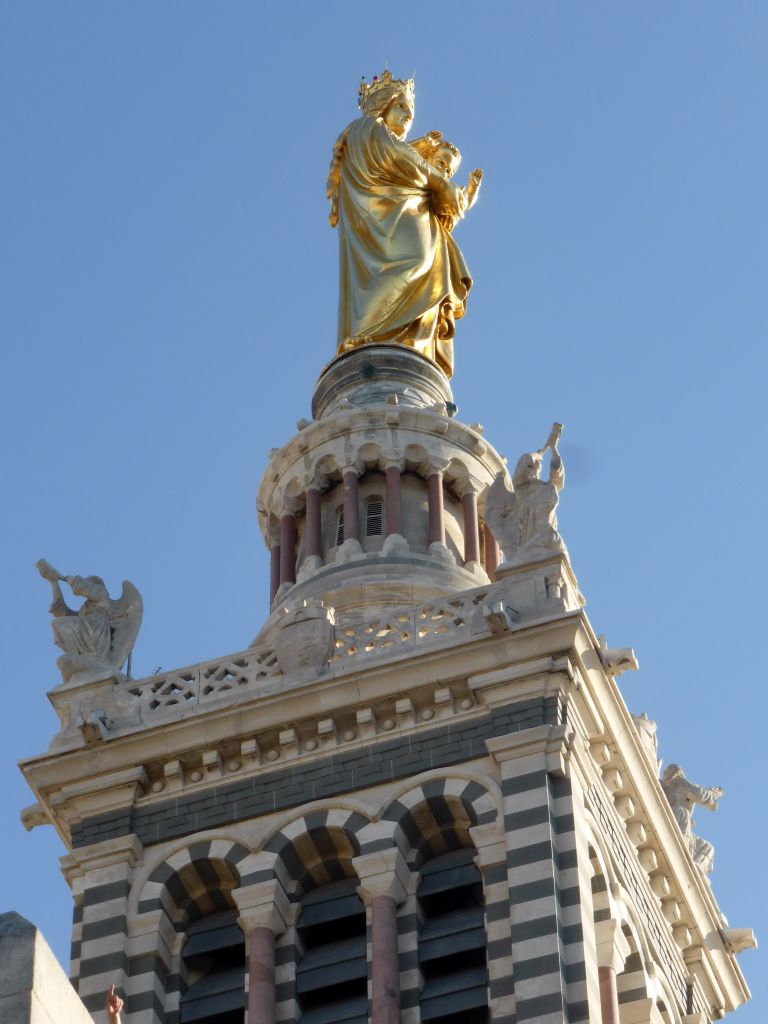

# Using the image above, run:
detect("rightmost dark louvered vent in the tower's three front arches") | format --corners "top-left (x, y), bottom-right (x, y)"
top-left (419, 850), bottom-right (488, 1024)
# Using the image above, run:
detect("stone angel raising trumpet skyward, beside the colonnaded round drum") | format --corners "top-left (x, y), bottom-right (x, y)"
top-left (485, 423), bottom-right (567, 565)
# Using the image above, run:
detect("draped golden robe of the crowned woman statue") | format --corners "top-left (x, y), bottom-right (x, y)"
top-left (336, 116), bottom-right (472, 377)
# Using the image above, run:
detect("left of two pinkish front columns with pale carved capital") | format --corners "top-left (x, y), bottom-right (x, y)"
top-left (232, 878), bottom-right (291, 1024)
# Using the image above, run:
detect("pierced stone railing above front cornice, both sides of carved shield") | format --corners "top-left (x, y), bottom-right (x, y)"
top-left (121, 588), bottom-right (488, 716)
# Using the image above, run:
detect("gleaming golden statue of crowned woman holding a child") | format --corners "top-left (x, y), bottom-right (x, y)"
top-left (328, 71), bottom-right (482, 377)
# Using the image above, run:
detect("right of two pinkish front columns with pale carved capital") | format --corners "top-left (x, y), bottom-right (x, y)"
top-left (352, 847), bottom-right (409, 1024)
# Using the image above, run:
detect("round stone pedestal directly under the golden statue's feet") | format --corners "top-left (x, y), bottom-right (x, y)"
top-left (312, 345), bottom-right (456, 420)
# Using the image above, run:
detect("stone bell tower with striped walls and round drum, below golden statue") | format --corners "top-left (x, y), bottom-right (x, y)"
top-left (23, 74), bottom-right (750, 1024)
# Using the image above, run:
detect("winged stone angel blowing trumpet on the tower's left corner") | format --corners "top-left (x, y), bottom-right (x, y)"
top-left (35, 558), bottom-right (143, 684)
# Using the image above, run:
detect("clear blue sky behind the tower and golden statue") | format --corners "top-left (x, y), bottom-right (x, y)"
top-left (0, 0), bottom-right (768, 1024)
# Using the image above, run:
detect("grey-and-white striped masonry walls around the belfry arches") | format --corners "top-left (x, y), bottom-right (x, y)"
top-left (48, 663), bottom-right (745, 1024)
